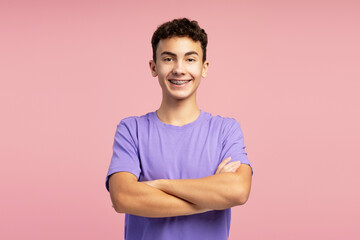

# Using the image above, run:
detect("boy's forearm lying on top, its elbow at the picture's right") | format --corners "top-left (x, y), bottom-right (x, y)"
top-left (148, 165), bottom-right (250, 210)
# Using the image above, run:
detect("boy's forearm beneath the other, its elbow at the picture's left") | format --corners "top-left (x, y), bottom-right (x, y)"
top-left (110, 173), bottom-right (210, 217)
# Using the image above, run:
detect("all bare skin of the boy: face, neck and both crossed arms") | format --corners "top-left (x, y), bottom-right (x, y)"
top-left (109, 37), bottom-right (252, 217)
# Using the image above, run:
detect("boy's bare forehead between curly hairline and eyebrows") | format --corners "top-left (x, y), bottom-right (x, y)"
top-left (156, 37), bottom-right (202, 57)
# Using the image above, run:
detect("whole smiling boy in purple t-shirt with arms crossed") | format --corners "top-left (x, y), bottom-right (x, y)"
top-left (106, 18), bottom-right (252, 240)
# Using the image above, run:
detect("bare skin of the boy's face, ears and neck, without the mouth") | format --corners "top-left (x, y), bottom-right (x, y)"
top-left (149, 37), bottom-right (209, 126)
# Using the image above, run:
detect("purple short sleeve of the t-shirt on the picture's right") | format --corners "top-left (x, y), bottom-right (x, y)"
top-left (221, 118), bottom-right (253, 173)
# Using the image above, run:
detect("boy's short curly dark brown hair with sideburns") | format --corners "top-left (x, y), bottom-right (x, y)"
top-left (151, 18), bottom-right (208, 62)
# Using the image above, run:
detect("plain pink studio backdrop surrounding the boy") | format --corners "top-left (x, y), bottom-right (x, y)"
top-left (0, 0), bottom-right (360, 240)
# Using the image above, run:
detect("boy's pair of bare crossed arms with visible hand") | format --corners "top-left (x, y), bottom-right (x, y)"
top-left (109, 158), bottom-right (252, 217)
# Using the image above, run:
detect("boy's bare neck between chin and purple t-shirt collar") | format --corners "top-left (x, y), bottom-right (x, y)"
top-left (156, 94), bottom-right (200, 126)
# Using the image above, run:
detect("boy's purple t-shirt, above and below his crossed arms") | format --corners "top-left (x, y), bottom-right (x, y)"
top-left (106, 110), bottom-right (251, 240)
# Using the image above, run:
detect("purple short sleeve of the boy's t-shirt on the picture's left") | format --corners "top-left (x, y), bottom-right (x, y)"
top-left (105, 121), bottom-right (141, 191)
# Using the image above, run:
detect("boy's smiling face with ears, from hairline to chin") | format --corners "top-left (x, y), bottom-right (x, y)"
top-left (150, 37), bottom-right (209, 100)
